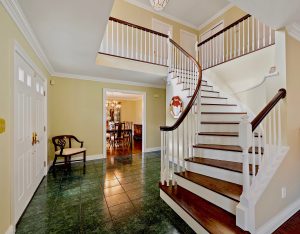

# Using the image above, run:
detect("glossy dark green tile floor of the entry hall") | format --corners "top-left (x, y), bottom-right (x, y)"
top-left (16, 152), bottom-right (193, 234)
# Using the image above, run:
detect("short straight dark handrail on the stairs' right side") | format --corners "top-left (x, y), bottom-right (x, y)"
top-left (251, 89), bottom-right (286, 131)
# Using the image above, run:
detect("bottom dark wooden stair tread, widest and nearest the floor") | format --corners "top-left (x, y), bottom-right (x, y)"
top-left (160, 184), bottom-right (247, 233)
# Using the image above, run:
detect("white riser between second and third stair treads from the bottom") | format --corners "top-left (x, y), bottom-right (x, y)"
top-left (186, 161), bottom-right (243, 185)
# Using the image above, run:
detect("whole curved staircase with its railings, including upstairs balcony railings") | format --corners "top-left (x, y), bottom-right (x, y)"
top-left (99, 15), bottom-right (288, 233)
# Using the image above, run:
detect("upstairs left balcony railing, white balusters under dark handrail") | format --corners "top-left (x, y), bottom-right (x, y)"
top-left (99, 17), bottom-right (168, 66)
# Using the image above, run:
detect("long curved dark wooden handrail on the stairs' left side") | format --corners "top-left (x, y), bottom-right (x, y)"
top-left (160, 39), bottom-right (202, 132)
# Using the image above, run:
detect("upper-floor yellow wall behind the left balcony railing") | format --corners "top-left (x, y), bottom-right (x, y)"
top-left (111, 0), bottom-right (198, 42)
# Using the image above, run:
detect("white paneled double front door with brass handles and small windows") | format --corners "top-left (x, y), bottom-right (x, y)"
top-left (14, 53), bottom-right (46, 223)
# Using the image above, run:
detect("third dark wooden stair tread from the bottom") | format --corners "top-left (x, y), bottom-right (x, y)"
top-left (186, 157), bottom-right (258, 175)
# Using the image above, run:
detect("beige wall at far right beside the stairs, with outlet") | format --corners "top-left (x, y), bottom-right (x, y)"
top-left (256, 33), bottom-right (300, 227)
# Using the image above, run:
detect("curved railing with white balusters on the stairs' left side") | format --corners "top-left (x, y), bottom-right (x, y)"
top-left (160, 39), bottom-right (202, 186)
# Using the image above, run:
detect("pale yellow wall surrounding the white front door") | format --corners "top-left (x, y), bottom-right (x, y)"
top-left (0, 4), bottom-right (48, 233)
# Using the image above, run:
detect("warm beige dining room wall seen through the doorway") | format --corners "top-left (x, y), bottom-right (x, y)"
top-left (118, 100), bottom-right (143, 124)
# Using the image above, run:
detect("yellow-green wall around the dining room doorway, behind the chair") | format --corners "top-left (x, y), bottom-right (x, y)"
top-left (48, 77), bottom-right (166, 158)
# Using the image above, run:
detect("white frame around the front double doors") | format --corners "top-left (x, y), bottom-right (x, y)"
top-left (10, 41), bottom-right (48, 227)
